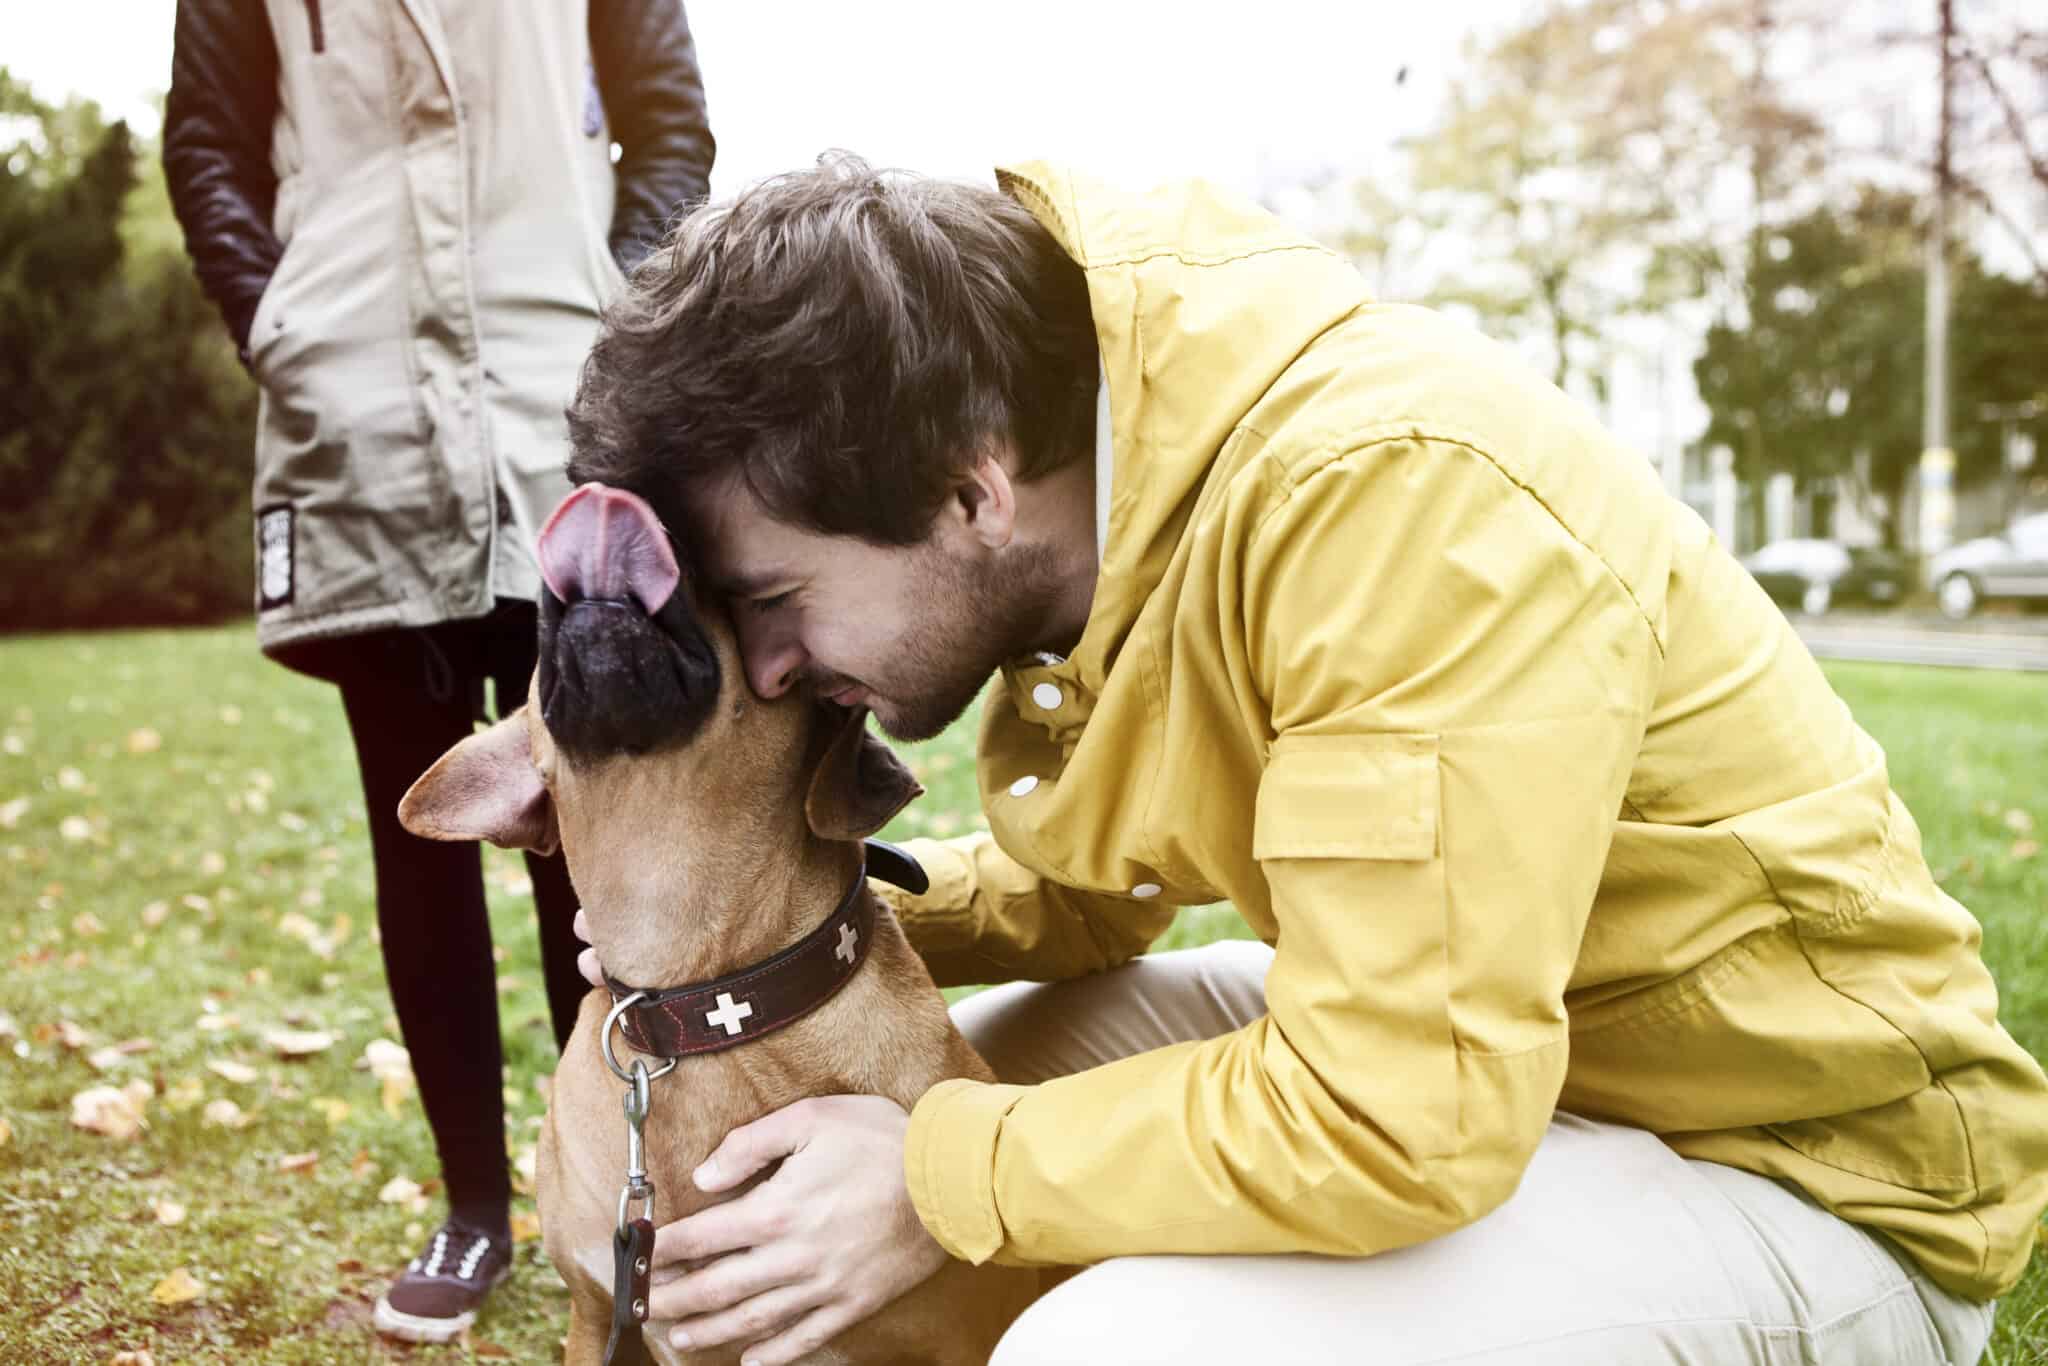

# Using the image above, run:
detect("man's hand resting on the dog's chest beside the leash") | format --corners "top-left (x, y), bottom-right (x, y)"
top-left (649, 1096), bottom-right (946, 1366)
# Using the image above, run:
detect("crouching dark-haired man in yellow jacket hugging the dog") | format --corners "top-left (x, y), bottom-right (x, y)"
top-left (571, 160), bottom-right (2048, 1366)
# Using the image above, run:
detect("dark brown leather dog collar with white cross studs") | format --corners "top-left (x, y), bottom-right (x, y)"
top-left (604, 840), bottom-right (928, 1057)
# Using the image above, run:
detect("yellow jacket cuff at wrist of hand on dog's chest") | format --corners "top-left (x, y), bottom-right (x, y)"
top-left (903, 1079), bottom-right (1030, 1264)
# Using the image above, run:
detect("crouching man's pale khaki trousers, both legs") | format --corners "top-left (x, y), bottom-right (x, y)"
top-left (954, 944), bottom-right (1991, 1366)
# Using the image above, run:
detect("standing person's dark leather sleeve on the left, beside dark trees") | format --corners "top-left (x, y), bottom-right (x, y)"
top-left (164, 0), bottom-right (283, 362)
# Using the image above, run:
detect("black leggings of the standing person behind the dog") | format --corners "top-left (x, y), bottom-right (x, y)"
top-left (330, 602), bottom-right (590, 1225)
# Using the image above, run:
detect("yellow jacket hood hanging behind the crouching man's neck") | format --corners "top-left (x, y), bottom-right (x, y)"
top-left (995, 162), bottom-right (1368, 688)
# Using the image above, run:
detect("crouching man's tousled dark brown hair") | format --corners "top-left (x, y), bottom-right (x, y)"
top-left (569, 154), bottom-right (1098, 545)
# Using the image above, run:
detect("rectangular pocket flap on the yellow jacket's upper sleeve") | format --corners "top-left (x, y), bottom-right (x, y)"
top-left (1251, 733), bottom-right (1440, 860)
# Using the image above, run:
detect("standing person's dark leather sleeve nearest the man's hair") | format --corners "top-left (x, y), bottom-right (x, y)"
top-left (590, 0), bottom-right (717, 270)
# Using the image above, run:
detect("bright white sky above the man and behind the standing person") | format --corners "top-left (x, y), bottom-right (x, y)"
top-left (0, 0), bottom-right (1526, 197)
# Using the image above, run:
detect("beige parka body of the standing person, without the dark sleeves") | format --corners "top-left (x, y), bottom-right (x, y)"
top-left (236, 0), bottom-right (655, 651)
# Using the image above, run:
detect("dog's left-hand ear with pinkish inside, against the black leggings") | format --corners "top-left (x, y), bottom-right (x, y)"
top-left (397, 707), bottom-right (561, 854)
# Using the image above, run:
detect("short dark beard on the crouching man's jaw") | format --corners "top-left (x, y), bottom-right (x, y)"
top-left (868, 545), bottom-right (1057, 741)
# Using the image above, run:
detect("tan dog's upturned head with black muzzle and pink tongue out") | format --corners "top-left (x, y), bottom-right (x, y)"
top-left (399, 483), bottom-right (922, 885)
